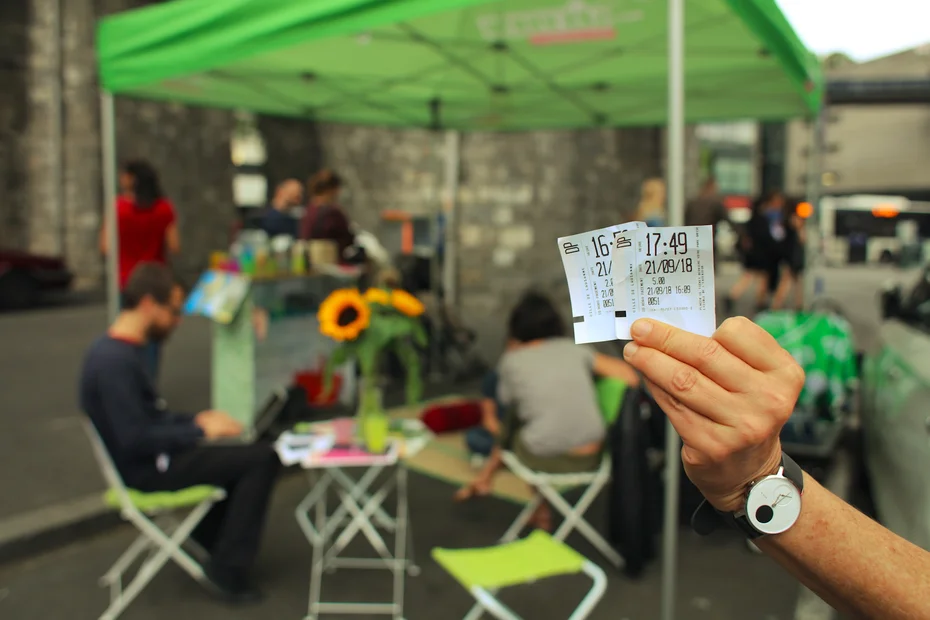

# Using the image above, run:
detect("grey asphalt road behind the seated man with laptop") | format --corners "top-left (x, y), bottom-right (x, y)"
top-left (0, 305), bottom-right (210, 520)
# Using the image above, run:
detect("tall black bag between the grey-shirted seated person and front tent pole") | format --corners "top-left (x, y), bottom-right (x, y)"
top-left (607, 389), bottom-right (662, 578)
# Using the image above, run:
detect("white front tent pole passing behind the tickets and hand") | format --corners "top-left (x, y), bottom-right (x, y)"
top-left (662, 0), bottom-right (685, 620)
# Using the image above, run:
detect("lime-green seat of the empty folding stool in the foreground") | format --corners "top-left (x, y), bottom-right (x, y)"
top-left (433, 530), bottom-right (587, 590)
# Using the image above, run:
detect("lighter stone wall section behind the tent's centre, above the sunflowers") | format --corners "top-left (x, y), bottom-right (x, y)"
top-left (319, 126), bottom-right (698, 359)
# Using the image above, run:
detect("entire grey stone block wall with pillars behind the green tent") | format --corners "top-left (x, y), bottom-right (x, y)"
top-left (0, 0), bottom-right (698, 360)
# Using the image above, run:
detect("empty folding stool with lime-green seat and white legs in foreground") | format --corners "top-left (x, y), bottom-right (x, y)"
top-left (433, 530), bottom-right (607, 620)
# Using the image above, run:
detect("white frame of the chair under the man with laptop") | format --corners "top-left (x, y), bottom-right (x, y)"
top-left (84, 418), bottom-right (226, 620)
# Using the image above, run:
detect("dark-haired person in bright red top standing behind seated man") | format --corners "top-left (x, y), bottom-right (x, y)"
top-left (100, 160), bottom-right (181, 381)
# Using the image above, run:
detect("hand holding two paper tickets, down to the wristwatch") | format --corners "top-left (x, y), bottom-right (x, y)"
top-left (624, 317), bottom-right (804, 512)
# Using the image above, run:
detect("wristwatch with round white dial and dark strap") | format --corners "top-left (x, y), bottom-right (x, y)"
top-left (691, 452), bottom-right (804, 540)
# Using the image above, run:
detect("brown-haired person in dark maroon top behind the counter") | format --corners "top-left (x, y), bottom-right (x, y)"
top-left (300, 170), bottom-right (355, 263)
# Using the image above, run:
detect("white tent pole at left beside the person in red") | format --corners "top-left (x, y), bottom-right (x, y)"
top-left (100, 92), bottom-right (119, 323)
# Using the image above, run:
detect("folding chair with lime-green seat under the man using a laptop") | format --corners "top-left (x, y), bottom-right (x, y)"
top-left (84, 419), bottom-right (226, 620)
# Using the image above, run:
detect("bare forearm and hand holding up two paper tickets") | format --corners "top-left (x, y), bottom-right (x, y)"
top-left (624, 318), bottom-right (930, 620)
